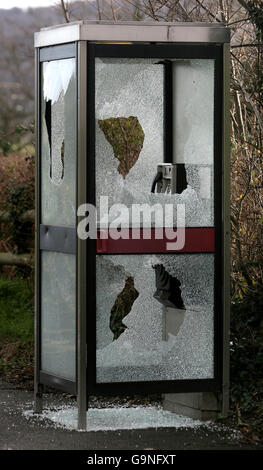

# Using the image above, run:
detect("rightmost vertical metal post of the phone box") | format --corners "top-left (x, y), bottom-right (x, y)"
top-left (222, 43), bottom-right (231, 417)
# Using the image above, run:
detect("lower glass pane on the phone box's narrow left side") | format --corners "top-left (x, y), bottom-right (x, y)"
top-left (41, 252), bottom-right (76, 381)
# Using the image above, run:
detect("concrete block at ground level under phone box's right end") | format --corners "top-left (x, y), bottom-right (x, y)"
top-left (163, 392), bottom-right (222, 421)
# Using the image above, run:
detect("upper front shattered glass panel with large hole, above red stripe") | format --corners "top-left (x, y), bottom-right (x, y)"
top-left (95, 58), bottom-right (214, 227)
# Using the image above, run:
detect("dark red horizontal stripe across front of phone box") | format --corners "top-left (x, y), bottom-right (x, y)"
top-left (97, 227), bottom-right (215, 254)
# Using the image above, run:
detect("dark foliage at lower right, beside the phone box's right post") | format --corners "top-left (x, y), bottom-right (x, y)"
top-left (230, 285), bottom-right (263, 417)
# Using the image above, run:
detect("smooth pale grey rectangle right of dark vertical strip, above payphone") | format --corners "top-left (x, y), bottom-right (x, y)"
top-left (173, 59), bottom-right (214, 165)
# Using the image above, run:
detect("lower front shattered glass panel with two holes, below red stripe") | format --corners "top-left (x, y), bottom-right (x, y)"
top-left (96, 254), bottom-right (214, 382)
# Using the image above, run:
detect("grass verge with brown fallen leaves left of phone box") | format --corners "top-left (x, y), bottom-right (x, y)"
top-left (0, 278), bottom-right (34, 389)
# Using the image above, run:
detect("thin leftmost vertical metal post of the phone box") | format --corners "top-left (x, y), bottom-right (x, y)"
top-left (34, 48), bottom-right (43, 413)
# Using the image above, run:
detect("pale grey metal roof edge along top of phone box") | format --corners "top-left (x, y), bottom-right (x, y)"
top-left (34, 21), bottom-right (230, 47)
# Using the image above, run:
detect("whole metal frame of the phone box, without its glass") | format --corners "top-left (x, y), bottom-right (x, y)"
top-left (35, 25), bottom-right (230, 428)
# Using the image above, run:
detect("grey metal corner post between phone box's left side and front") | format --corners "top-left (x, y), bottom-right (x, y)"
top-left (77, 41), bottom-right (87, 430)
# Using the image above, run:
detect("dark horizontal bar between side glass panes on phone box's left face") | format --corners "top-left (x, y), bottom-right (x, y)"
top-left (39, 224), bottom-right (77, 255)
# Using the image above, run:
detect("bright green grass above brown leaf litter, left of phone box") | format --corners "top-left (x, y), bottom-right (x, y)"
top-left (0, 278), bottom-right (34, 343)
